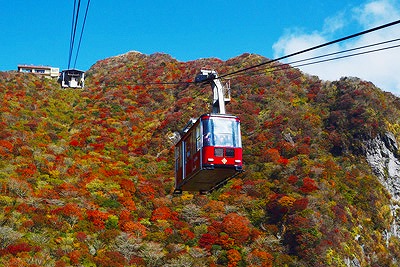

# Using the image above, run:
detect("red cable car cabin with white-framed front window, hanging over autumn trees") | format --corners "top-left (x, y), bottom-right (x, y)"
top-left (174, 114), bottom-right (242, 194)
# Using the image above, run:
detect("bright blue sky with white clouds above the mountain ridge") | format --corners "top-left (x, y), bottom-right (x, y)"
top-left (0, 0), bottom-right (400, 94)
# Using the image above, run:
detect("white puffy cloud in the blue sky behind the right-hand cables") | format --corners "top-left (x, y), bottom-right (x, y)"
top-left (273, 0), bottom-right (400, 95)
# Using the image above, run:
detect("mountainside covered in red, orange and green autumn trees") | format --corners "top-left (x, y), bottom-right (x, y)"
top-left (0, 52), bottom-right (400, 267)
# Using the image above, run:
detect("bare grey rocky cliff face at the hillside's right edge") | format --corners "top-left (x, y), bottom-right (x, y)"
top-left (365, 132), bottom-right (400, 239)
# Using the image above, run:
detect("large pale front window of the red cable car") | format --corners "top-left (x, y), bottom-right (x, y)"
top-left (203, 117), bottom-right (242, 147)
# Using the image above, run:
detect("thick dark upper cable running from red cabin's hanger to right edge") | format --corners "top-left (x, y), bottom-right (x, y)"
top-left (219, 20), bottom-right (400, 78)
